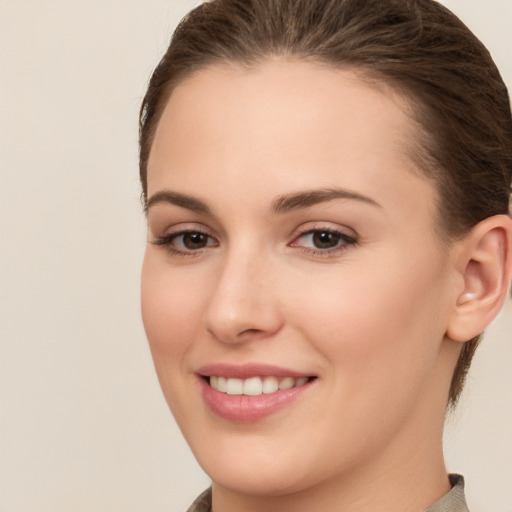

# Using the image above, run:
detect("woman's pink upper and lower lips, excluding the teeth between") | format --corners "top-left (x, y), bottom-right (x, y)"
top-left (197, 364), bottom-right (316, 423)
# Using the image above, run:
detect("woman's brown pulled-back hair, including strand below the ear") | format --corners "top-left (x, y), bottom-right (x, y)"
top-left (140, 0), bottom-right (512, 405)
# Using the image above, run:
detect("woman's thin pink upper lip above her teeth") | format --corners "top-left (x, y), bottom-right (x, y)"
top-left (197, 363), bottom-right (314, 379)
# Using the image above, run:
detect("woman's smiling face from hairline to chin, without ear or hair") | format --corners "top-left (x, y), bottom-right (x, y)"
top-left (142, 60), bottom-right (456, 494)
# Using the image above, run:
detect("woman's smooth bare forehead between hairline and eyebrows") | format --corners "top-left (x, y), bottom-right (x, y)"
top-left (148, 58), bottom-right (430, 221)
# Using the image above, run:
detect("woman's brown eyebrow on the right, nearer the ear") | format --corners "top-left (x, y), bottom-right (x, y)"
top-left (272, 188), bottom-right (382, 213)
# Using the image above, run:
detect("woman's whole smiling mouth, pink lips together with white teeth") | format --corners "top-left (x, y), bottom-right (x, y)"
top-left (197, 364), bottom-right (317, 423)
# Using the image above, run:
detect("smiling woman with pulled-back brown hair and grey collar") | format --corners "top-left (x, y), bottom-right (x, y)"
top-left (140, 0), bottom-right (512, 512)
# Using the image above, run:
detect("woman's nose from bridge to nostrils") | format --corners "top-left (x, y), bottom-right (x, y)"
top-left (205, 247), bottom-right (283, 344)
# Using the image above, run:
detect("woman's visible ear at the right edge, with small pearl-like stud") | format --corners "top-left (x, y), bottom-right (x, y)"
top-left (446, 215), bottom-right (512, 342)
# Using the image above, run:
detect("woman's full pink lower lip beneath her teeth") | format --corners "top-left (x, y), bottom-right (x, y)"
top-left (199, 378), bottom-right (316, 423)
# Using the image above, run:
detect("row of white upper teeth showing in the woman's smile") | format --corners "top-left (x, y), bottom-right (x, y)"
top-left (210, 375), bottom-right (309, 396)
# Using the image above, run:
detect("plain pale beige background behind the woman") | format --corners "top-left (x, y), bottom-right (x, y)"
top-left (0, 0), bottom-right (512, 512)
